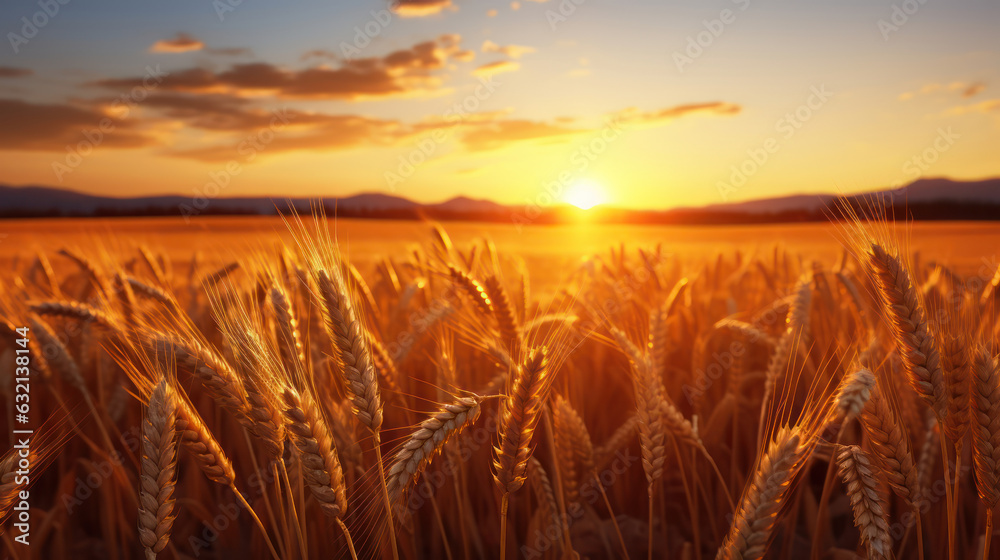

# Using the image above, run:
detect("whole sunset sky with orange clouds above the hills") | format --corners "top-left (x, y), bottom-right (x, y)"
top-left (0, 0), bottom-right (1000, 208)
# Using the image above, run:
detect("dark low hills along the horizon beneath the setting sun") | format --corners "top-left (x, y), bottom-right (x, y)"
top-left (0, 178), bottom-right (1000, 224)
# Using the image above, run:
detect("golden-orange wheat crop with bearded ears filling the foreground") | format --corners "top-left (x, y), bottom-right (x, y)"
top-left (0, 216), bottom-right (1000, 560)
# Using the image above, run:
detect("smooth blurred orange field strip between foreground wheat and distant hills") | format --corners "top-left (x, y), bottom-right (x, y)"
top-left (0, 217), bottom-right (1000, 289)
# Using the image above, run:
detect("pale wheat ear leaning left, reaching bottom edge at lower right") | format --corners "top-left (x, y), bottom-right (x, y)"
top-left (837, 445), bottom-right (892, 560)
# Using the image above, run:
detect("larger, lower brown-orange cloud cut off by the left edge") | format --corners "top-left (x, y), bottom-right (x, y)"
top-left (0, 99), bottom-right (155, 152)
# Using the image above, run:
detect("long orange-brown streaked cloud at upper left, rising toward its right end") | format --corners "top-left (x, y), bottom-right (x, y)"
top-left (91, 35), bottom-right (461, 100)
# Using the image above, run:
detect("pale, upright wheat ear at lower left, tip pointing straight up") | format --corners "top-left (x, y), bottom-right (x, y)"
top-left (139, 379), bottom-right (177, 560)
